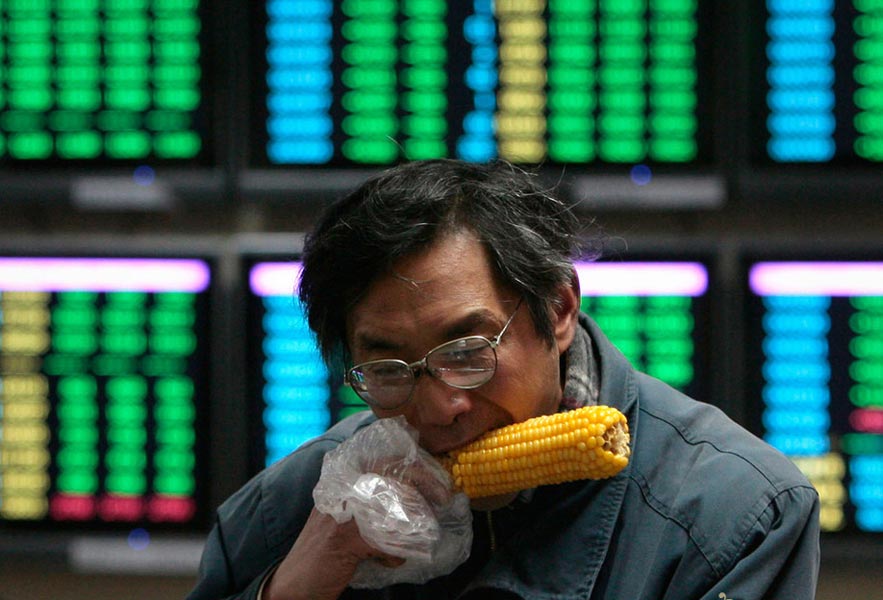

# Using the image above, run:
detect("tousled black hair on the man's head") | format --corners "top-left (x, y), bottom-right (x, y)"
top-left (299, 159), bottom-right (596, 366)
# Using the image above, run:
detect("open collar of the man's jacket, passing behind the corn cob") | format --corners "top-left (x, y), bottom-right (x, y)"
top-left (464, 315), bottom-right (638, 600)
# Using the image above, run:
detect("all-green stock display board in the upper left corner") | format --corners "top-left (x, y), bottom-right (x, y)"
top-left (0, 0), bottom-right (208, 165)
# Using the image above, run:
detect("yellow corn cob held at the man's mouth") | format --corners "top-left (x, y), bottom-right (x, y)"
top-left (441, 406), bottom-right (631, 498)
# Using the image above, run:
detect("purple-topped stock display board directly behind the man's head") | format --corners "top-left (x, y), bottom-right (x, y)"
top-left (248, 255), bottom-right (708, 470)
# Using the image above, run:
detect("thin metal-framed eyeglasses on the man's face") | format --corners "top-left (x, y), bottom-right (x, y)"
top-left (344, 299), bottom-right (523, 410)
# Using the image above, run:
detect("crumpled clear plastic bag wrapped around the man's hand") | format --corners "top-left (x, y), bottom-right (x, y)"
top-left (313, 416), bottom-right (472, 589)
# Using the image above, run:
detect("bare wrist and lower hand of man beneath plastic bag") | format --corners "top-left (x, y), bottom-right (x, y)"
top-left (263, 509), bottom-right (404, 600)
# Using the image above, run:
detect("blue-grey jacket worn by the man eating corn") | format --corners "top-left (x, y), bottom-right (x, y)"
top-left (189, 318), bottom-right (819, 600)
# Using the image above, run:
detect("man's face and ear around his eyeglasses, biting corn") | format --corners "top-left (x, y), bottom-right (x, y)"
top-left (347, 231), bottom-right (579, 454)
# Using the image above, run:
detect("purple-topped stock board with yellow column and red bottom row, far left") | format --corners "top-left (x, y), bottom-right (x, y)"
top-left (0, 257), bottom-right (210, 526)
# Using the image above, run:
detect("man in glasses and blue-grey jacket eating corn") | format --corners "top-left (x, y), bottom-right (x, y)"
top-left (191, 160), bottom-right (818, 600)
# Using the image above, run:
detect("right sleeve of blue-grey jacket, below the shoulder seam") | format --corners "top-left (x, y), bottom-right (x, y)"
top-left (702, 486), bottom-right (819, 600)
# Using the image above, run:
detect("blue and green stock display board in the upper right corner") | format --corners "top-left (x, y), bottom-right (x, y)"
top-left (752, 0), bottom-right (883, 164)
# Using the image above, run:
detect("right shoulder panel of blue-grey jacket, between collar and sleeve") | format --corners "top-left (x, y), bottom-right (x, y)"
top-left (631, 373), bottom-right (818, 572)
